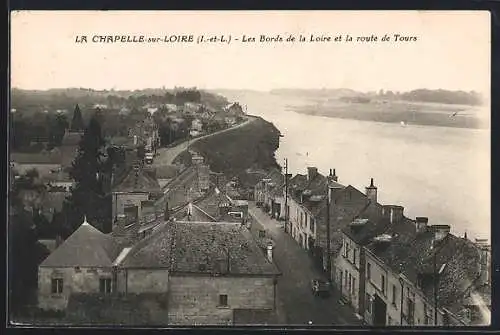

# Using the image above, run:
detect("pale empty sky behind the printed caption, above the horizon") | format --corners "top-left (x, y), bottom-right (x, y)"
top-left (11, 11), bottom-right (491, 94)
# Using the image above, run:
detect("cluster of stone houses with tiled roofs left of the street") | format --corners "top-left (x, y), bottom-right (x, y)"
top-left (34, 145), bottom-right (280, 326)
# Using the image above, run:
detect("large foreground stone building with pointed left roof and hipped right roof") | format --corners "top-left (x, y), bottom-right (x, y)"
top-left (38, 220), bottom-right (280, 325)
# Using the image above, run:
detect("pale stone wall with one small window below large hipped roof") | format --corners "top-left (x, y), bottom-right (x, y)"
top-left (168, 276), bottom-right (274, 325)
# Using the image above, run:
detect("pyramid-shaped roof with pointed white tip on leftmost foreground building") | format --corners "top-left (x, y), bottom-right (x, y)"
top-left (40, 222), bottom-right (121, 267)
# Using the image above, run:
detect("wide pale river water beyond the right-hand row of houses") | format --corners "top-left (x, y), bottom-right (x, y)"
top-left (219, 91), bottom-right (491, 239)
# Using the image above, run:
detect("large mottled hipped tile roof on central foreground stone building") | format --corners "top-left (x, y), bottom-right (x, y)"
top-left (119, 221), bottom-right (279, 275)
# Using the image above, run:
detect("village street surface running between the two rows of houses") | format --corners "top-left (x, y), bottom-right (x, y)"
top-left (249, 202), bottom-right (362, 326)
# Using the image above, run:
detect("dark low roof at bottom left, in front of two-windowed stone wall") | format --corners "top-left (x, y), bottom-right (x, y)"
top-left (66, 293), bottom-right (168, 326)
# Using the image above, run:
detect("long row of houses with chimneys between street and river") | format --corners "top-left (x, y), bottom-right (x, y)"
top-left (254, 167), bottom-right (491, 326)
